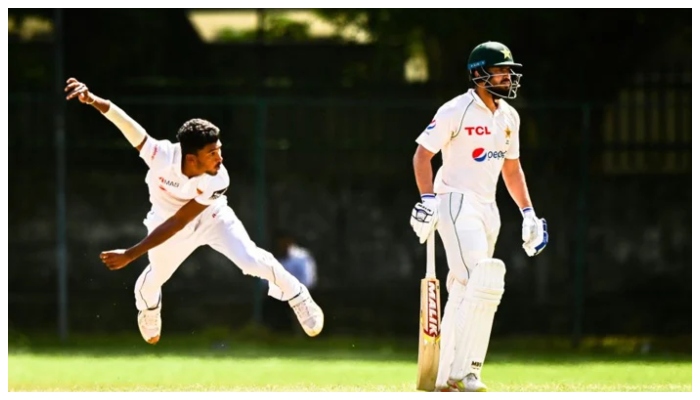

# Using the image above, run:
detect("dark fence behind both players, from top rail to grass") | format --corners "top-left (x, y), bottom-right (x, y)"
top-left (8, 83), bottom-right (691, 342)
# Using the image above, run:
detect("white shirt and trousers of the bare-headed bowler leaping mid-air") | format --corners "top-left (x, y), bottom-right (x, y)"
top-left (134, 137), bottom-right (301, 310)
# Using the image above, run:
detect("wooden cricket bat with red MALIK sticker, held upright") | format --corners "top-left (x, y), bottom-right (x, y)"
top-left (416, 232), bottom-right (441, 392)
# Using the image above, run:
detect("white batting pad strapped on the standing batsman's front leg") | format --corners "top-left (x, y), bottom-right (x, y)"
top-left (450, 258), bottom-right (506, 380)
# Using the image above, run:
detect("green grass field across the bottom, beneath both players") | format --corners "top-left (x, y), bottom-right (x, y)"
top-left (8, 332), bottom-right (692, 392)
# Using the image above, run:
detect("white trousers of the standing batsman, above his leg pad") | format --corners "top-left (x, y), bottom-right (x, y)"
top-left (437, 192), bottom-right (501, 290)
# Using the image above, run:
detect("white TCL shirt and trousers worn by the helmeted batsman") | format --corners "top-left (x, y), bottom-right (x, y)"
top-left (416, 89), bottom-right (520, 282)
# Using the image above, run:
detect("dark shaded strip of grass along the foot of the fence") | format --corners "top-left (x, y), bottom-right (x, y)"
top-left (9, 328), bottom-right (692, 364)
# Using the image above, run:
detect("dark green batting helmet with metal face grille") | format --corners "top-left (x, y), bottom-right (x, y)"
top-left (467, 42), bottom-right (523, 99)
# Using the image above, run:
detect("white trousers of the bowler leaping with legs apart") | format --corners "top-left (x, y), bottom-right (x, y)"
top-left (134, 205), bottom-right (301, 310)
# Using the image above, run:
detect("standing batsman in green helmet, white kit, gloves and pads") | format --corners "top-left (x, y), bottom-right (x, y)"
top-left (411, 42), bottom-right (548, 392)
